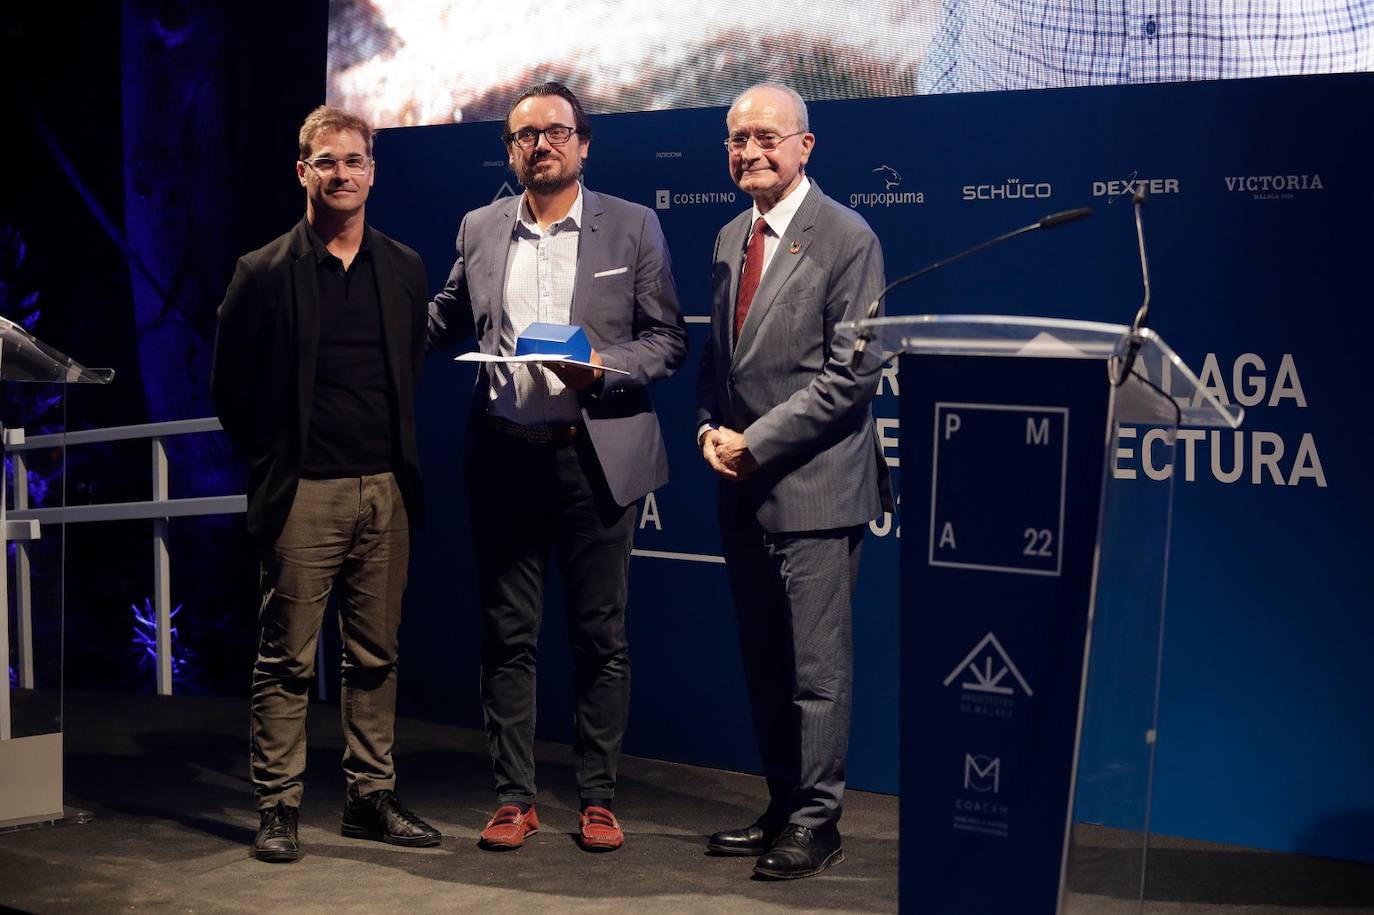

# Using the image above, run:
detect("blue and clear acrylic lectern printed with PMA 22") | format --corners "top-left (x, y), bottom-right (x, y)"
top-left (840, 315), bottom-right (1242, 915)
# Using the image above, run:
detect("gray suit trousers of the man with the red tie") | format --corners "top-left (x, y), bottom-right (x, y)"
top-left (721, 518), bottom-right (863, 828)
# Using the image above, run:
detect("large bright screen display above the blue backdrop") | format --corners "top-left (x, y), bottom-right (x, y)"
top-left (327, 0), bottom-right (1374, 128)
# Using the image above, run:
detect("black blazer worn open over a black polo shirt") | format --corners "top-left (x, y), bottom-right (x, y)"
top-left (210, 218), bottom-right (429, 556)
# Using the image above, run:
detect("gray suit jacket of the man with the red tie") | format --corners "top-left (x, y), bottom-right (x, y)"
top-left (697, 181), bottom-right (892, 532)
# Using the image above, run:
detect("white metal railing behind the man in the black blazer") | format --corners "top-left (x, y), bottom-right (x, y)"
top-left (0, 416), bottom-right (247, 700)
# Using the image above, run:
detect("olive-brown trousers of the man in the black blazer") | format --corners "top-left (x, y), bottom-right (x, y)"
top-left (250, 473), bottom-right (411, 809)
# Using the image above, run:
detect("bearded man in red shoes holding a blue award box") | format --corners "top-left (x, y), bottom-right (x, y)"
top-left (430, 82), bottom-right (687, 852)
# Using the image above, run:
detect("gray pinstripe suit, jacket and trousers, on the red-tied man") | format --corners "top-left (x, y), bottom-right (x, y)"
top-left (697, 181), bottom-right (890, 828)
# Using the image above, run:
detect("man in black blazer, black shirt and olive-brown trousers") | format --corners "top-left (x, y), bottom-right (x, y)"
top-left (210, 106), bottom-right (440, 861)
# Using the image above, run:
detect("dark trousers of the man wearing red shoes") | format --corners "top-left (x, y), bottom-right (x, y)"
top-left (469, 426), bottom-right (635, 804)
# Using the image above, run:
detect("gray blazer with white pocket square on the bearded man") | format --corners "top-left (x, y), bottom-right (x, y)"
top-left (429, 188), bottom-right (687, 506)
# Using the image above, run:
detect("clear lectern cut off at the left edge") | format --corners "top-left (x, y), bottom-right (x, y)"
top-left (0, 317), bottom-right (114, 828)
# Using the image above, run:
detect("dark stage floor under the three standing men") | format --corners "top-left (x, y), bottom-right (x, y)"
top-left (0, 692), bottom-right (1374, 915)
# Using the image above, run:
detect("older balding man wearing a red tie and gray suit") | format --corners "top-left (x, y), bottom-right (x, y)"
top-left (697, 82), bottom-right (890, 878)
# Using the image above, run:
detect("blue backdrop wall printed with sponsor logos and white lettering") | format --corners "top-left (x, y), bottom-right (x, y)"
top-left (370, 74), bottom-right (1374, 860)
